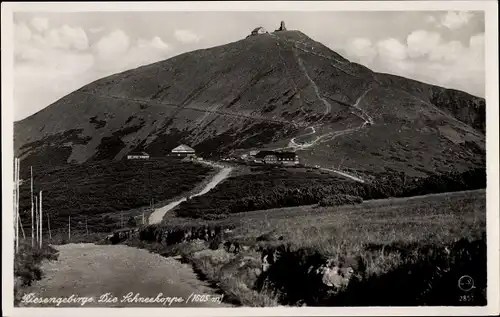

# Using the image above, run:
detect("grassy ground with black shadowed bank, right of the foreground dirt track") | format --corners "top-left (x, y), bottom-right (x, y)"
top-left (139, 190), bottom-right (486, 306)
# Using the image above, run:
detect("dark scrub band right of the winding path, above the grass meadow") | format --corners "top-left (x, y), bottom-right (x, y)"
top-left (176, 168), bottom-right (486, 219)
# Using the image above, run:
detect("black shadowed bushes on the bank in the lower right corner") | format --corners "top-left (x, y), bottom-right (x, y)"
top-left (255, 234), bottom-right (487, 307)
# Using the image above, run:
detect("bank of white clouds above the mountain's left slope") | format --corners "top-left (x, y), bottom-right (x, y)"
top-left (14, 23), bottom-right (171, 119)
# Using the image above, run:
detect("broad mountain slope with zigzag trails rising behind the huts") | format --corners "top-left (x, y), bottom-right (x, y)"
top-left (15, 31), bottom-right (485, 175)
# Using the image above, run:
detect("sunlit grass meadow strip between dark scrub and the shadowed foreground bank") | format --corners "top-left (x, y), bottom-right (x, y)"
top-left (224, 191), bottom-right (486, 255)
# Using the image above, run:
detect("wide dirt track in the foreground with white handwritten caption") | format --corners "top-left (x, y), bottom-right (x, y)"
top-left (21, 244), bottom-right (228, 307)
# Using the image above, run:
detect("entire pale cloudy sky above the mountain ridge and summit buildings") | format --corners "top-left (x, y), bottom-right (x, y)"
top-left (14, 11), bottom-right (485, 120)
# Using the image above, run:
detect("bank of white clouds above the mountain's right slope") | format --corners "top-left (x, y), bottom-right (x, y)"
top-left (345, 30), bottom-right (485, 96)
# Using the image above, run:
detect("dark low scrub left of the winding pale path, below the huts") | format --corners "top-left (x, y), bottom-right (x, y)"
top-left (20, 159), bottom-right (211, 236)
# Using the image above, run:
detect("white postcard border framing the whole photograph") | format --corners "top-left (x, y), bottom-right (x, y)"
top-left (2, 0), bottom-right (500, 317)
